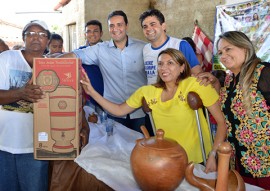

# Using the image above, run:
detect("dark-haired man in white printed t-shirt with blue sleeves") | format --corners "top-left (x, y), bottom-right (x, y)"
top-left (139, 9), bottom-right (202, 84)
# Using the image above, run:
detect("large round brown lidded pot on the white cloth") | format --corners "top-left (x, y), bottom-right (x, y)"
top-left (130, 129), bottom-right (188, 191)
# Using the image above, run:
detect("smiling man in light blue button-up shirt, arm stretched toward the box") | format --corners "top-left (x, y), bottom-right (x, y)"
top-left (61, 11), bottom-right (151, 134)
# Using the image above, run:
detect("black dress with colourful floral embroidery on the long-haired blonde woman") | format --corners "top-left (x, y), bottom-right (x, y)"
top-left (220, 63), bottom-right (270, 178)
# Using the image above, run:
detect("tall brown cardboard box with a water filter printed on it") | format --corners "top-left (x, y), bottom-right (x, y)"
top-left (33, 58), bottom-right (82, 160)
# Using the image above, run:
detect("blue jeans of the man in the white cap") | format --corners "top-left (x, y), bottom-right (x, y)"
top-left (0, 151), bottom-right (48, 191)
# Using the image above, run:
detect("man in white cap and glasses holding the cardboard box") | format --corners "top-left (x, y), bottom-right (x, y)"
top-left (0, 20), bottom-right (51, 191)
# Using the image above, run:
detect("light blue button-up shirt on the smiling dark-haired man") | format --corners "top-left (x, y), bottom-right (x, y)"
top-left (73, 37), bottom-right (147, 119)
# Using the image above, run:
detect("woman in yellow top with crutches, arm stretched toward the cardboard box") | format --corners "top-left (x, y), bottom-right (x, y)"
top-left (81, 48), bottom-right (226, 172)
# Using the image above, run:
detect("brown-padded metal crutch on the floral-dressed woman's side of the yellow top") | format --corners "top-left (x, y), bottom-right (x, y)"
top-left (187, 92), bottom-right (206, 166)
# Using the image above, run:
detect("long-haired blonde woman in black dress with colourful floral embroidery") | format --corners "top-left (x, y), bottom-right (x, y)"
top-left (198, 31), bottom-right (270, 189)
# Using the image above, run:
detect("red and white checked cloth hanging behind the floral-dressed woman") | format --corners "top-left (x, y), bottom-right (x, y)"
top-left (192, 25), bottom-right (213, 72)
